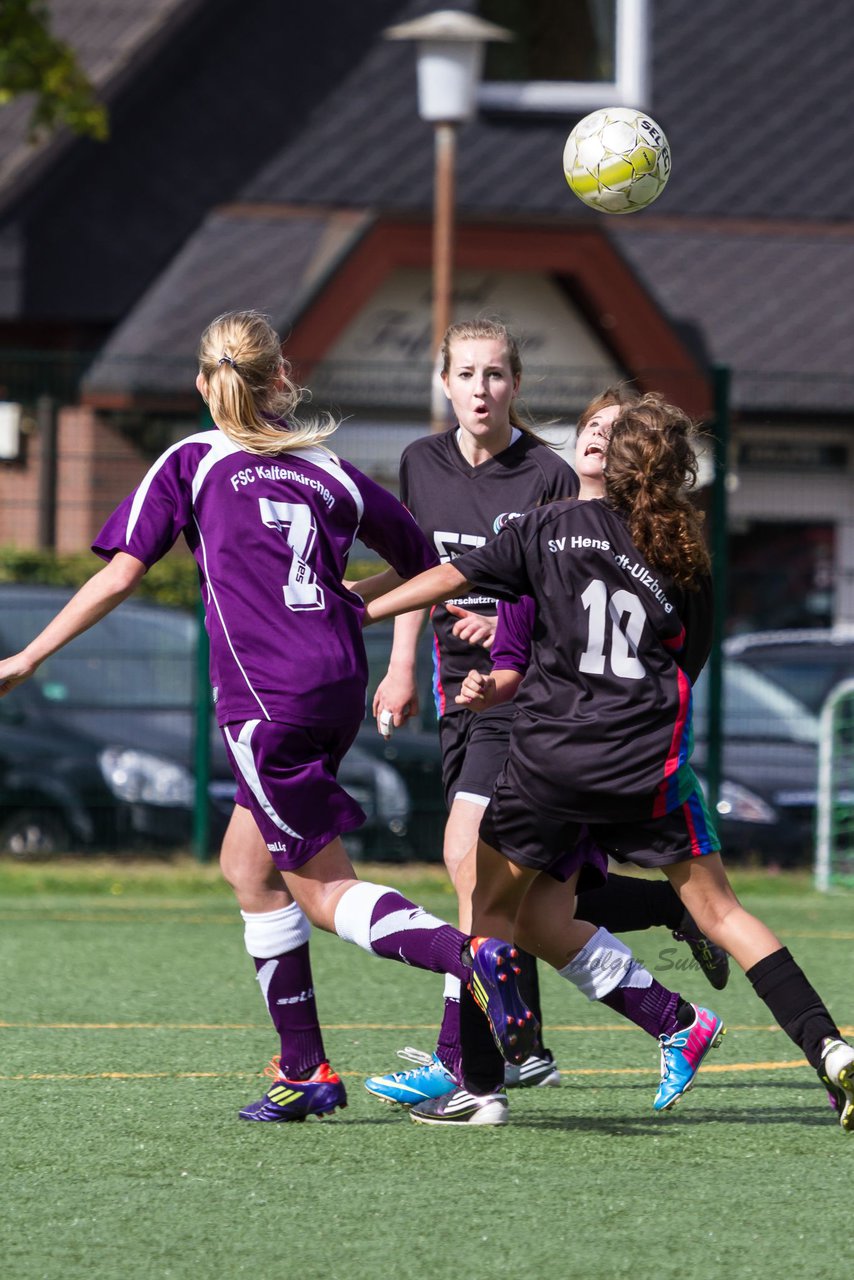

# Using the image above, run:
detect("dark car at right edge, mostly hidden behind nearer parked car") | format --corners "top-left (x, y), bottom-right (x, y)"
top-left (725, 626), bottom-right (854, 714)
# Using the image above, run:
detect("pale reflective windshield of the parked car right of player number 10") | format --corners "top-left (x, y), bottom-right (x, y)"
top-left (694, 660), bottom-right (818, 742)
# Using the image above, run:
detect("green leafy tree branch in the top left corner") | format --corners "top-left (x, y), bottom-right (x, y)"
top-left (0, 0), bottom-right (109, 141)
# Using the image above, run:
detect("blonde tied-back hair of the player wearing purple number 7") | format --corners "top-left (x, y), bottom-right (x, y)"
top-left (198, 311), bottom-right (338, 454)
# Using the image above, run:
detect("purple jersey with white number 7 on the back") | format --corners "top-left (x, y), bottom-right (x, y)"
top-left (92, 430), bottom-right (435, 726)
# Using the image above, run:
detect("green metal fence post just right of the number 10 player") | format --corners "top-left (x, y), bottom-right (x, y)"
top-left (705, 365), bottom-right (730, 815)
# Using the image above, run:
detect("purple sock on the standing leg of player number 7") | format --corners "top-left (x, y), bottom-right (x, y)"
top-left (252, 942), bottom-right (326, 1080)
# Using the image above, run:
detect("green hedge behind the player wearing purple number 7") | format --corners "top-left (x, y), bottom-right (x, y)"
top-left (0, 547), bottom-right (379, 609)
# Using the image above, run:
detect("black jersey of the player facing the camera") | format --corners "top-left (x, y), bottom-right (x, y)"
top-left (401, 429), bottom-right (579, 716)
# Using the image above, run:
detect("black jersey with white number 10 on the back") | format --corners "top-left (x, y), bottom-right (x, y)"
top-left (456, 500), bottom-right (695, 822)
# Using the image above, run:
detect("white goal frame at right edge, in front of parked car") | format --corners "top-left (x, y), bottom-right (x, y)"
top-left (814, 680), bottom-right (854, 891)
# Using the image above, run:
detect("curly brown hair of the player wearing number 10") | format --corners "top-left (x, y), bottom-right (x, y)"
top-left (604, 392), bottom-right (709, 586)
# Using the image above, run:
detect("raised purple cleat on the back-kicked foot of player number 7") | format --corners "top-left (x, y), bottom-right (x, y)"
top-left (469, 938), bottom-right (539, 1066)
